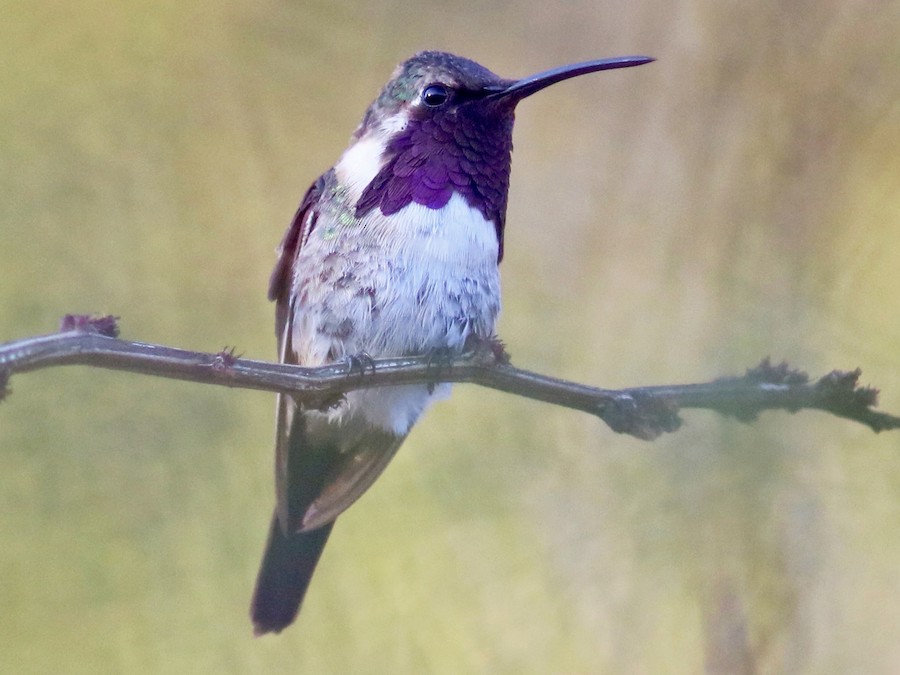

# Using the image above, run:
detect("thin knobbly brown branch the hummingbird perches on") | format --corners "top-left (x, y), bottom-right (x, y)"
top-left (0, 315), bottom-right (900, 439)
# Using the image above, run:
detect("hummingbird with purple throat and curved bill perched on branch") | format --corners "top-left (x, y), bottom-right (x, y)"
top-left (250, 51), bottom-right (653, 635)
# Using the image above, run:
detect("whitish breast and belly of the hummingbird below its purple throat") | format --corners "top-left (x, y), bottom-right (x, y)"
top-left (291, 194), bottom-right (500, 434)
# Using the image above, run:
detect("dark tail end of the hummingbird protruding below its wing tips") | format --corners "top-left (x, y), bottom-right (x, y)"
top-left (250, 516), bottom-right (334, 635)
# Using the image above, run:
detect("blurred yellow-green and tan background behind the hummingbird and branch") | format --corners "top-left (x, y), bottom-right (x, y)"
top-left (0, 0), bottom-right (900, 673)
